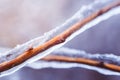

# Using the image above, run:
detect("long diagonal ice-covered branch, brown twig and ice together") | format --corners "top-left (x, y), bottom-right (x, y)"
top-left (0, 0), bottom-right (120, 76)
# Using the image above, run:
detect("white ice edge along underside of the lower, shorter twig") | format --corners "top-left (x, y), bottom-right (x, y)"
top-left (27, 61), bottom-right (120, 76)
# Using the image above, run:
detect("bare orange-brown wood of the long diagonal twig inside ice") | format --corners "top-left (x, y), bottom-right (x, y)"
top-left (0, 1), bottom-right (120, 72)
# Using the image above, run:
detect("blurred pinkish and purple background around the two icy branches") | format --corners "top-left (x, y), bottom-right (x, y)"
top-left (0, 0), bottom-right (120, 80)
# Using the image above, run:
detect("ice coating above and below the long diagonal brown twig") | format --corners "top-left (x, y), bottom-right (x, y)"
top-left (0, 0), bottom-right (120, 76)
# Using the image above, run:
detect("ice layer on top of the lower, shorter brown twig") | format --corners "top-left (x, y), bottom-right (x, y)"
top-left (53, 47), bottom-right (120, 65)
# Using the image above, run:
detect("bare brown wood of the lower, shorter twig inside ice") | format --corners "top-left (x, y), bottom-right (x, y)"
top-left (42, 55), bottom-right (120, 72)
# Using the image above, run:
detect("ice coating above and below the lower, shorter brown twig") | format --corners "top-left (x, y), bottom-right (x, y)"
top-left (27, 47), bottom-right (120, 75)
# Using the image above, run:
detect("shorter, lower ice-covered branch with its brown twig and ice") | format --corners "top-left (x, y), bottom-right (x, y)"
top-left (27, 47), bottom-right (120, 75)
